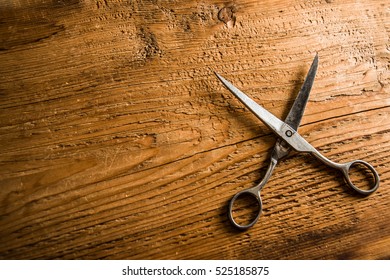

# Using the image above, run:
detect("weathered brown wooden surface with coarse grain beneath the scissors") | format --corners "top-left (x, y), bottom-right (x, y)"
top-left (0, 0), bottom-right (390, 259)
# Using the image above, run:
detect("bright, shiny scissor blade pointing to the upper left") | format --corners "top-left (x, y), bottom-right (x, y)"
top-left (214, 72), bottom-right (286, 137)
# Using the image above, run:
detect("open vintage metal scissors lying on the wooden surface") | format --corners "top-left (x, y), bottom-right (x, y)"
top-left (215, 54), bottom-right (379, 230)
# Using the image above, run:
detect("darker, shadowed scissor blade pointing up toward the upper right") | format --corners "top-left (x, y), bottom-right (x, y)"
top-left (285, 54), bottom-right (318, 130)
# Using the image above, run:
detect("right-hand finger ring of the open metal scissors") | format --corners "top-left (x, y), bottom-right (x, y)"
top-left (340, 160), bottom-right (379, 195)
